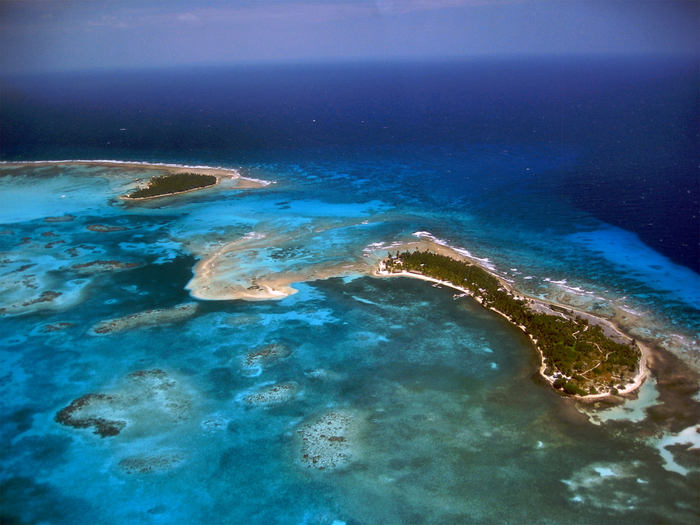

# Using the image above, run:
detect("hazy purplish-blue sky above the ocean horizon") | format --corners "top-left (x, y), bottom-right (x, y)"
top-left (0, 0), bottom-right (700, 73)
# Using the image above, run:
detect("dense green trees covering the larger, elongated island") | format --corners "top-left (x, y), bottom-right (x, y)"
top-left (383, 251), bottom-right (641, 396)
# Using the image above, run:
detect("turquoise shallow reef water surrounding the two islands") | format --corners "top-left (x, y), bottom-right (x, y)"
top-left (0, 158), bottom-right (698, 524)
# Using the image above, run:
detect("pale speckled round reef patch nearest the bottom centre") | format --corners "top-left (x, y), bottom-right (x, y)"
top-left (297, 410), bottom-right (359, 470)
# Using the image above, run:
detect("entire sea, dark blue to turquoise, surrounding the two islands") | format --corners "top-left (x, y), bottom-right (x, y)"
top-left (0, 57), bottom-right (700, 525)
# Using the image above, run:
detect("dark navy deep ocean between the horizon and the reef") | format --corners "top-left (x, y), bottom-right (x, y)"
top-left (0, 57), bottom-right (700, 272)
